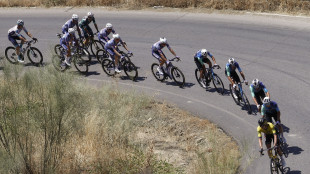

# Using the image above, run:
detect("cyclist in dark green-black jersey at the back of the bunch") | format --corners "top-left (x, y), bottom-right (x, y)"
top-left (79, 12), bottom-right (99, 45)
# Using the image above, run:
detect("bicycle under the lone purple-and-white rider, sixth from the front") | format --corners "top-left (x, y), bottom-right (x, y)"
top-left (151, 57), bottom-right (185, 87)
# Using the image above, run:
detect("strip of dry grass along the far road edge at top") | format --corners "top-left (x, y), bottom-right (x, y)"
top-left (0, 0), bottom-right (310, 14)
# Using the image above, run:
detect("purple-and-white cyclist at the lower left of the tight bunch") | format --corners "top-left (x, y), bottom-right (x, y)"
top-left (60, 28), bottom-right (78, 66)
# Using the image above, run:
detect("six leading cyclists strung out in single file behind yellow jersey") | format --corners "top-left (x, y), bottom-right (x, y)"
top-left (152, 38), bottom-right (286, 167)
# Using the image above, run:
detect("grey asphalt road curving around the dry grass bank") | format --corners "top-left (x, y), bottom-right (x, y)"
top-left (0, 8), bottom-right (310, 173)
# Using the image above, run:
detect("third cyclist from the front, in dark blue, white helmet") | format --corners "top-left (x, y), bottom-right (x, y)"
top-left (250, 79), bottom-right (270, 112)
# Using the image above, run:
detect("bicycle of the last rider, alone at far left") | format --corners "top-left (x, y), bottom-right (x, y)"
top-left (5, 40), bottom-right (43, 66)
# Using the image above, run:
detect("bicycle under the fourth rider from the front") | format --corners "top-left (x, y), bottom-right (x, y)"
top-left (229, 82), bottom-right (252, 114)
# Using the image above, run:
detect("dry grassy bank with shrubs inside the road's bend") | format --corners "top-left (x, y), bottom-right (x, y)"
top-left (0, 61), bottom-right (240, 174)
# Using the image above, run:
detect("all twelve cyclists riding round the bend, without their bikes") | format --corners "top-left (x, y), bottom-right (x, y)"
top-left (8, 12), bottom-right (286, 166)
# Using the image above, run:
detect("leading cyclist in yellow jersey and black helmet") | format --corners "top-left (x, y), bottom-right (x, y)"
top-left (257, 118), bottom-right (286, 167)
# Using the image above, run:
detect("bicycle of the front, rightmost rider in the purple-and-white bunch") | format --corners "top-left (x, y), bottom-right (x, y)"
top-left (101, 51), bottom-right (138, 81)
